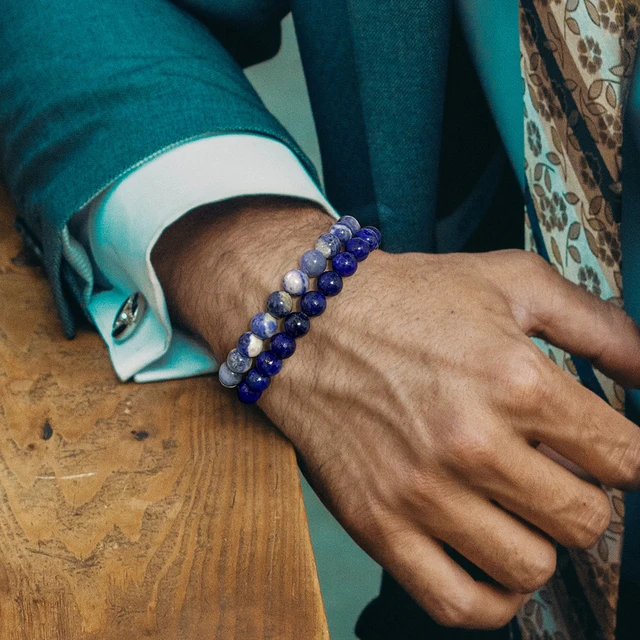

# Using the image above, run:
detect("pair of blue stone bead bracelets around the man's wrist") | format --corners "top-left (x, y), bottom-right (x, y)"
top-left (218, 216), bottom-right (382, 404)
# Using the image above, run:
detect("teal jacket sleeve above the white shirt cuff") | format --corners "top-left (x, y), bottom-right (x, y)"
top-left (0, 0), bottom-right (315, 337)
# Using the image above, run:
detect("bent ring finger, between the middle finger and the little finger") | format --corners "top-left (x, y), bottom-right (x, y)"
top-left (418, 491), bottom-right (556, 593)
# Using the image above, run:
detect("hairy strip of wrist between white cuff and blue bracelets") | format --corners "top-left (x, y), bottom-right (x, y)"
top-left (152, 197), bottom-right (331, 359)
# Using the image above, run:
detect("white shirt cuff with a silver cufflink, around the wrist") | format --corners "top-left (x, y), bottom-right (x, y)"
top-left (70, 134), bottom-right (338, 382)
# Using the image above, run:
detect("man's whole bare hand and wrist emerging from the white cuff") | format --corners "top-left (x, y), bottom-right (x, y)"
top-left (154, 199), bottom-right (640, 628)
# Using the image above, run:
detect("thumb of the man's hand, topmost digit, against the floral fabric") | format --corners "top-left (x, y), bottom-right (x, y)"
top-left (500, 252), bottom-right (640, 387)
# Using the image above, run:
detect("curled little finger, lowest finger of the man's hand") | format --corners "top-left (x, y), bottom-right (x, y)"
top-left (384, 530), bottom-right (530, 629)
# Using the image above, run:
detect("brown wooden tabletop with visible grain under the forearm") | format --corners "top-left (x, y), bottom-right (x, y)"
top-left (0, 188), bottom-right (328, 640)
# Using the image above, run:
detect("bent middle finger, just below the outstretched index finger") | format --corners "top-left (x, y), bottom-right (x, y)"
top-left (475, 442), bottom-right (611, 548)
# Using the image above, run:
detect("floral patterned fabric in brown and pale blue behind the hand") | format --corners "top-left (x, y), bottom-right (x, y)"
top-left (518, 0), bottom-right (640, 640)
